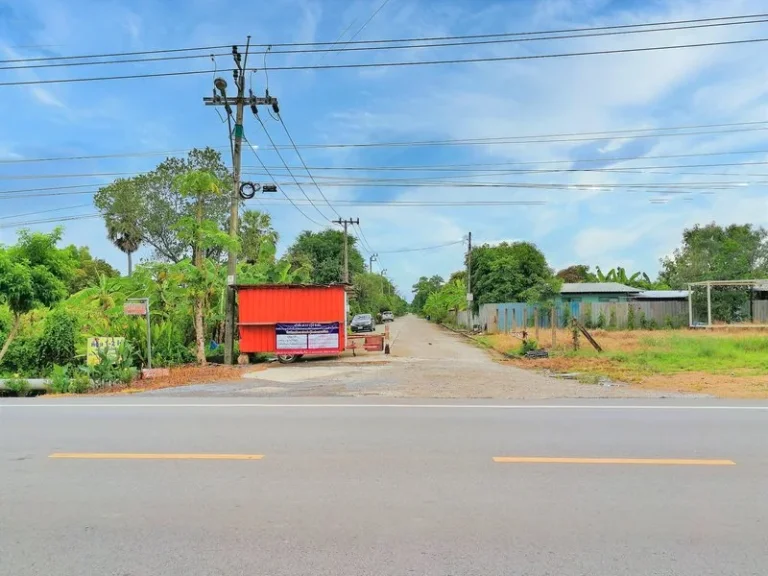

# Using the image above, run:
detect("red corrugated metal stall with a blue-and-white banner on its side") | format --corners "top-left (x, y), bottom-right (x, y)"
top-left (236, 284), bottom-right (347, 355)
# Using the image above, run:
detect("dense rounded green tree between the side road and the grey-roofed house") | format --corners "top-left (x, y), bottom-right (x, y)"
top-left (472, 242), bottom-right (558, 307)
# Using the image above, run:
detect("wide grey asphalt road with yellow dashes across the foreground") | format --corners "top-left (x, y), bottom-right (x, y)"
top-left (0, 396), bottom-right (768, 576)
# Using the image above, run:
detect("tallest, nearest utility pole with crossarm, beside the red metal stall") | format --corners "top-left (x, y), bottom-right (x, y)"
top-left (203, 36), bottom-right (279, 364)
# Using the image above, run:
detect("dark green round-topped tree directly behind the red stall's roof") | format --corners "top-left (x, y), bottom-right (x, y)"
top-left (288, 229), bottom-right (365, 284)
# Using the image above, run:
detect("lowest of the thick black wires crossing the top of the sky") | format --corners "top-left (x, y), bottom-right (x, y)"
top-left (0, 38), bottom-right (768, 86)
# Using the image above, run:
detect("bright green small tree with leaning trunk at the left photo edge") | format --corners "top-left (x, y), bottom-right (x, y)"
top-left (0, 228), bottom-right (72, 363)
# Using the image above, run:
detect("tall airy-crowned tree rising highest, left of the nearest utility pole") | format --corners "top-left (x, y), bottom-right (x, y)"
top-left (94, 148), bottom-right (232, 262)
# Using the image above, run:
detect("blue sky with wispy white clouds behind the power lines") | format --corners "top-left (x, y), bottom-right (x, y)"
top-left (0, 0), bottom-right (768, 293)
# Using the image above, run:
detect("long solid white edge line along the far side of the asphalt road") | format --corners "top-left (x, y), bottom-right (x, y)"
top-left (0, 401), bottom-right (768, 411)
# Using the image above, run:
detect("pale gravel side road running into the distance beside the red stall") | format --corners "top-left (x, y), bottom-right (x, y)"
top-left (142, 315), bottom-right (680, 399)
